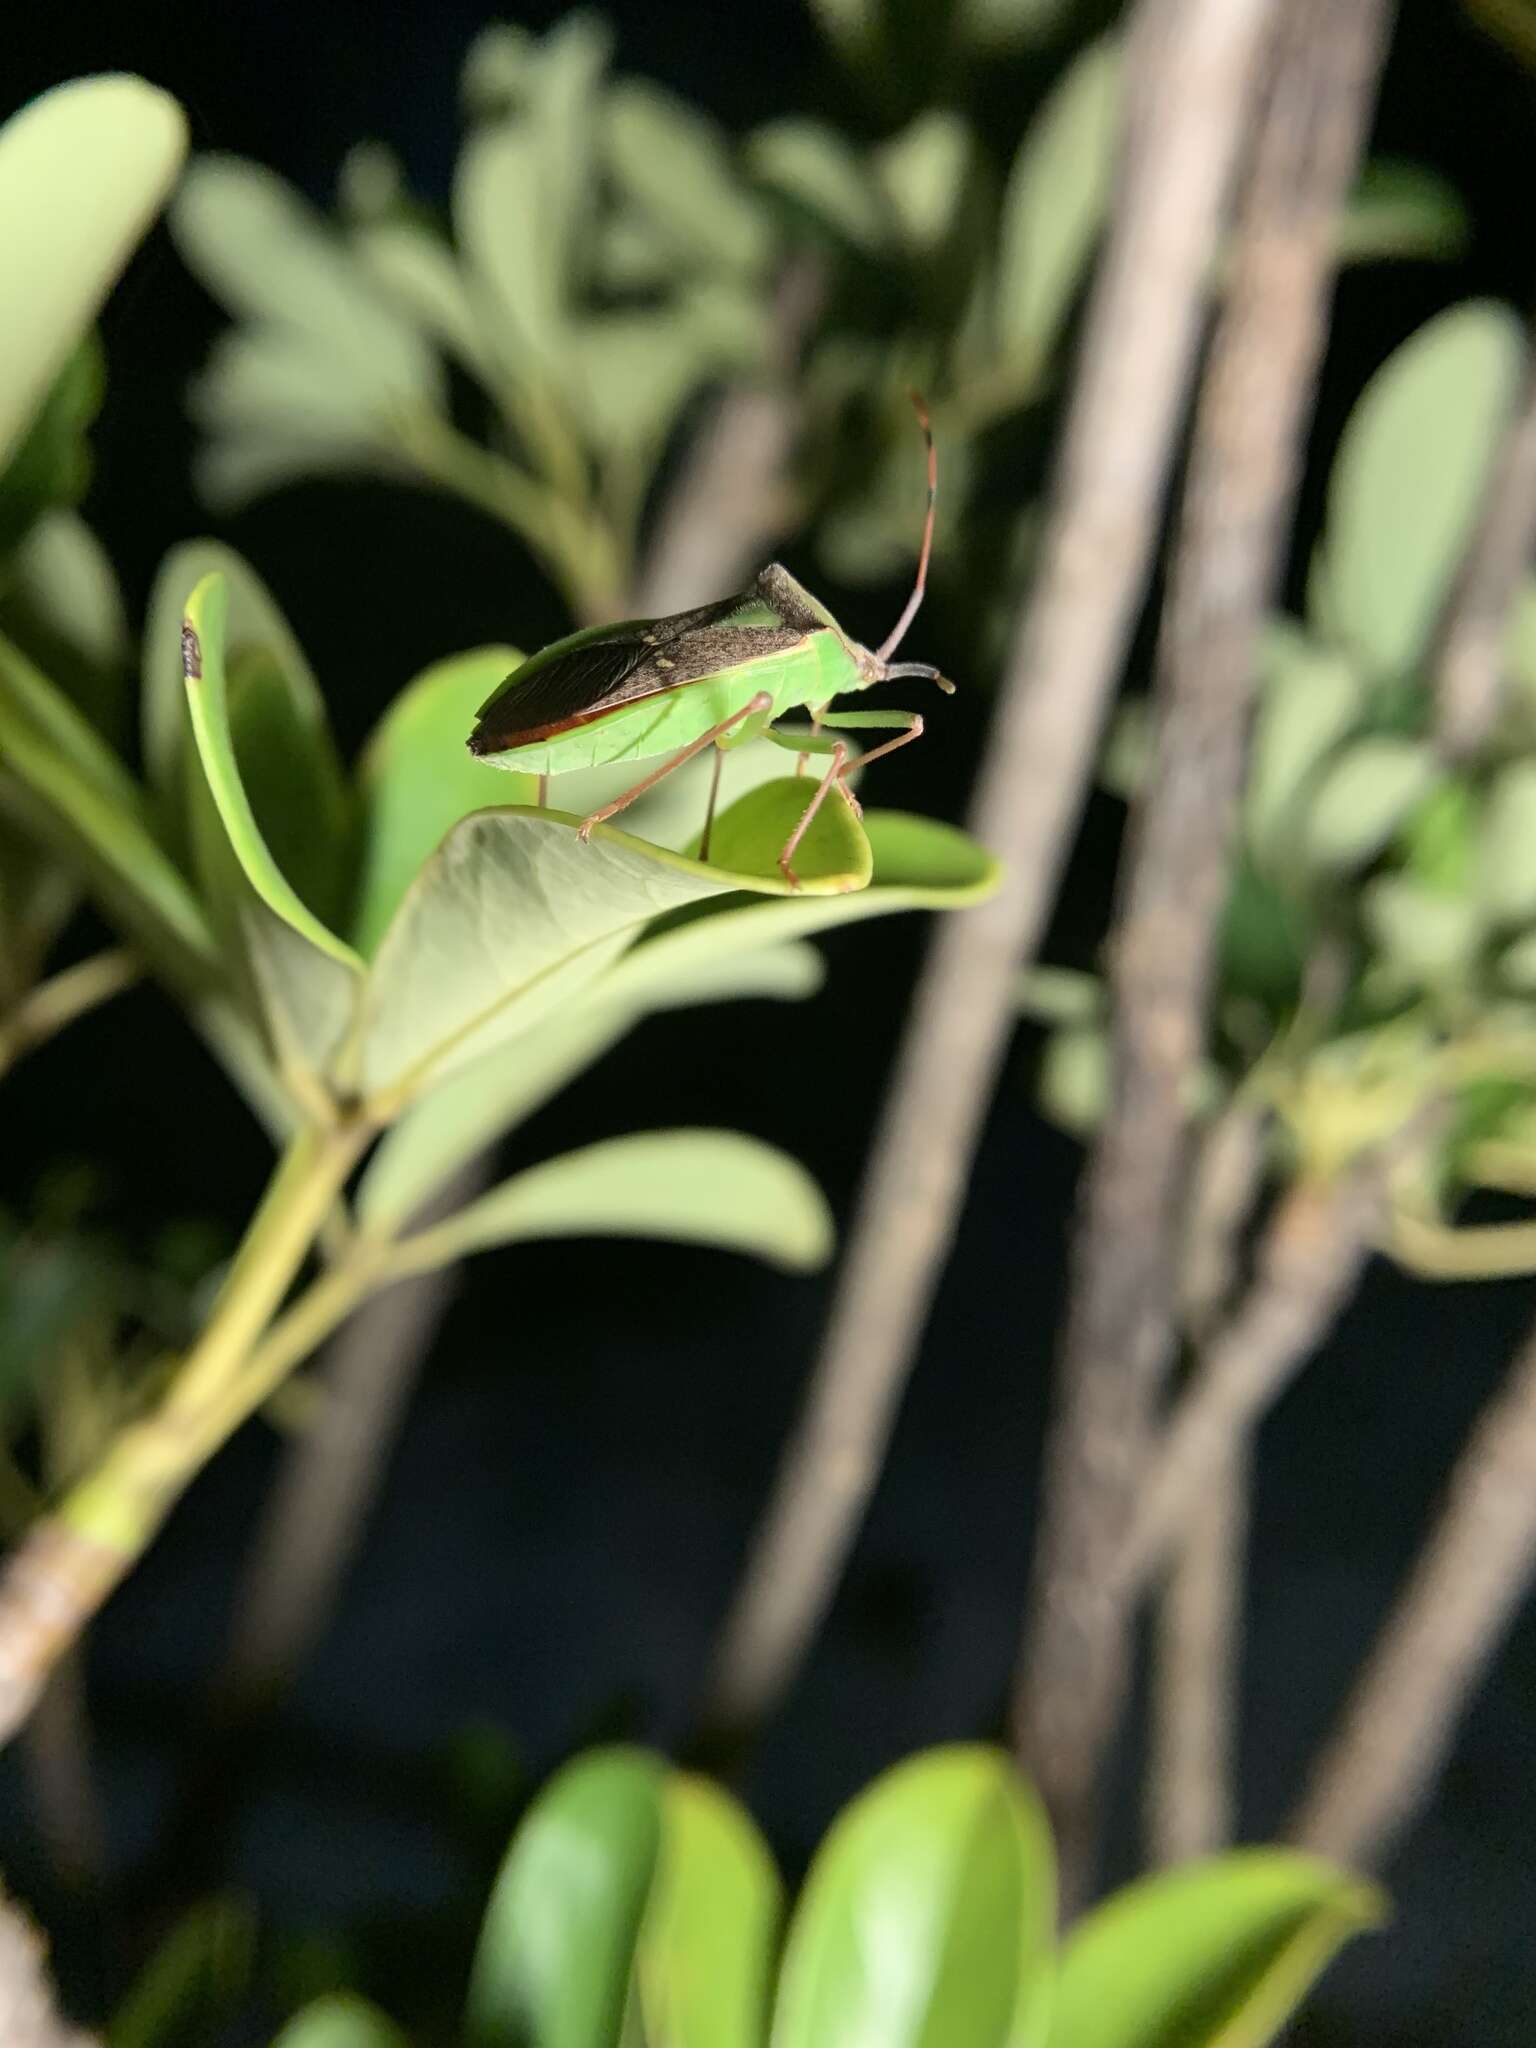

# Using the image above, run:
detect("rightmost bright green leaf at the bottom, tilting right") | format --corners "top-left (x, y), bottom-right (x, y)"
top-left (1051, 1849), bottom-right (1384, 2048)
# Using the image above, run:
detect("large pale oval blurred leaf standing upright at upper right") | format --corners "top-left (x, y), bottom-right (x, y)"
top-left (1323, 301), bottom-right (1526, 676)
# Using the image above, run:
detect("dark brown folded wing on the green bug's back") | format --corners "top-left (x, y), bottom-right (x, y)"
top-left (469, 588), bottom-right (801, 754)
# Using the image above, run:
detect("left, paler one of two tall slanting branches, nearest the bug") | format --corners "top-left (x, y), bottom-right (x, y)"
top-left (705, 0), bottom-right (1268, 1743)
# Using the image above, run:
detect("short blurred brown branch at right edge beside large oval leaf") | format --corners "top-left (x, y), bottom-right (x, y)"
top-left (1434, 352), bottom-right (1536, 760)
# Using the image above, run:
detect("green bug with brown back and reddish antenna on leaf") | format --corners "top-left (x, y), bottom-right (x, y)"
top-left (469, 393), bottom-right (954, 887)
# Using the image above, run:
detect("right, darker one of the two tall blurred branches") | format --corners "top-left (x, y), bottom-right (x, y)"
top-left (1016, 0), bottom-right (1389, 1901)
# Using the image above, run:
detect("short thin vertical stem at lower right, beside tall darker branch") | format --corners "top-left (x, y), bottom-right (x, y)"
top-left (1147, 1444), bottom-right (1249, 1864)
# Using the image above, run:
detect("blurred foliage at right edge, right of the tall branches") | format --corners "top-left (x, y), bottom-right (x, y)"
top-left (1022, 301), bottom-right (1536, 1274)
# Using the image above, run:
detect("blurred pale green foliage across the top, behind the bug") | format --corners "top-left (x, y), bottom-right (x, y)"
top-left (172, 0), bottom-right (1464, 651)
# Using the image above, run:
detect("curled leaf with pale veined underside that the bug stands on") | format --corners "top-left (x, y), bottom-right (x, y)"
top-left (362, 776), bottom-right (870, 1096)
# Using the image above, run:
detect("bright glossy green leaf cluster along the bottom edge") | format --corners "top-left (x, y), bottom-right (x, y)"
top-left (231, 1745), bottom-right (1382, 2048)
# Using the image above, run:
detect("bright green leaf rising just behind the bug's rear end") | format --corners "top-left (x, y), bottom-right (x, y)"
top-left (352, 647), bottom-right (539, 954)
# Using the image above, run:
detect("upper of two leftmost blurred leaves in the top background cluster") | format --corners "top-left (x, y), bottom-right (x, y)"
top-left (170, 156), bottom-right (440, 407)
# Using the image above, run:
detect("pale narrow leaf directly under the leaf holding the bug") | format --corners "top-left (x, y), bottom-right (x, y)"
top-left (356, 942), bottom-right (823, 1233)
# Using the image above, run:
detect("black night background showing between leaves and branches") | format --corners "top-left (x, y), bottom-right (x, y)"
top-left (0, 0), bottom-right (1536, 2048)
